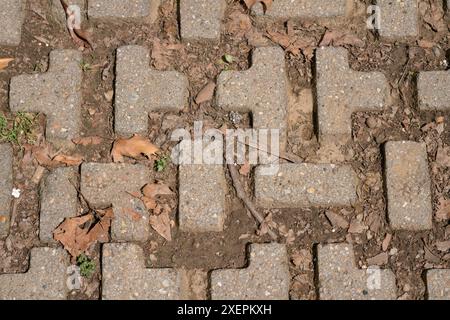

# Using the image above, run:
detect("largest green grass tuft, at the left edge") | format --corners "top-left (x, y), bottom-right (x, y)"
top-left (0, 112), bottom-right (36, 145)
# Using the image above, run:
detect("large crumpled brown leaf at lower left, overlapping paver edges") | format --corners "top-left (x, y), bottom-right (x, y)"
top-left (53, 208), bottom-right (113, 258)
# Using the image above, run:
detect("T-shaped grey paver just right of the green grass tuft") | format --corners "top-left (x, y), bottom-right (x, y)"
top-left (10, 50), bottom-right (82, 142)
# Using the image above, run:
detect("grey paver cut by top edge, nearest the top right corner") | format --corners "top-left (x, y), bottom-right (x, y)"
top-left (377, 0), bottom-right (419, 39)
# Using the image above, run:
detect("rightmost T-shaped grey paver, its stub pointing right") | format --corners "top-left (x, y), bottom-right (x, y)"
top-left (316, 47), bottom-right (389, 143)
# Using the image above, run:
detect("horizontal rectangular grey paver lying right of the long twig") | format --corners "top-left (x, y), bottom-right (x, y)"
top-left (255, 163), bottom-right (358, 208)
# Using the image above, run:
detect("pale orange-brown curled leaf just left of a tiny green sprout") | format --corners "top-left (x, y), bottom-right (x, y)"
top-left (111, 135), bottom-right (159, 162)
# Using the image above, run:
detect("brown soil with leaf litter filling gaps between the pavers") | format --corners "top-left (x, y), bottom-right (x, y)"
top-left (0, 0), bottom-right (450, 299)
